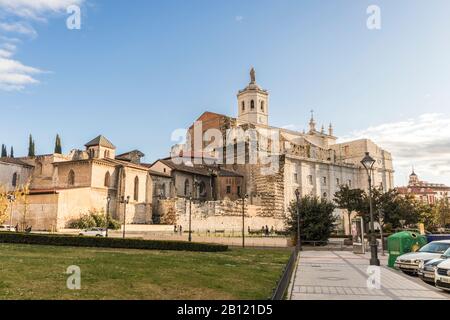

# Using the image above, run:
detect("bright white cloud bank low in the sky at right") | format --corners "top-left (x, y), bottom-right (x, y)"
top-left (342, 113), bottom-right (450, 185)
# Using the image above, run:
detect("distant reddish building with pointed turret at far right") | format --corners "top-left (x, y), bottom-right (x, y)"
top-left (397, 170), bottom-right (450, 205)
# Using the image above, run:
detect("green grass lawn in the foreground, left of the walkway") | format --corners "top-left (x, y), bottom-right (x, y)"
top-left (0, 244), bottom-right (290, 299)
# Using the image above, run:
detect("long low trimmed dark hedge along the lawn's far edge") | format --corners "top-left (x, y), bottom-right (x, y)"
top-left (0, 232), bottom-right (228, 252)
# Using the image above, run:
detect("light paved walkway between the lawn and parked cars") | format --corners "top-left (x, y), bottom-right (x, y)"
top-left (291, 251), bottom-right (450, 300)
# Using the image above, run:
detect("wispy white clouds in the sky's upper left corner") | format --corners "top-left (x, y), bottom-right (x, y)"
top-left (0, 0), bottom-right (85, 91)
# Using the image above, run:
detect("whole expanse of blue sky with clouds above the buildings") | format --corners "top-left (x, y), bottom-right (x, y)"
top-left (0, 0), bottom-right (450, 184)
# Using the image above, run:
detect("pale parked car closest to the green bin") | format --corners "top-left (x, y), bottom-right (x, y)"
top-left (394, 240), bottom-right (450, 275)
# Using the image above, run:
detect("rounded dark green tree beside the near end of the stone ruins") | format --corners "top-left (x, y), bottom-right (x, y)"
top-left (286, 196), bottom-right (336, 241)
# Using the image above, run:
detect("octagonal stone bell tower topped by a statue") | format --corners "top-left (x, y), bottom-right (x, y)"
top-left (237, 68), bottom-right (269, 125)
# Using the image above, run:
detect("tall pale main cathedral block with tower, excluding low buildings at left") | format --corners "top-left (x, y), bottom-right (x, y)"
top-left (172, 69), bottom-right (394, 232)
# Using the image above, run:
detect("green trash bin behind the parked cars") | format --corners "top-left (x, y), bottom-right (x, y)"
top-left (388, 231), bottom-right (428, 268)
